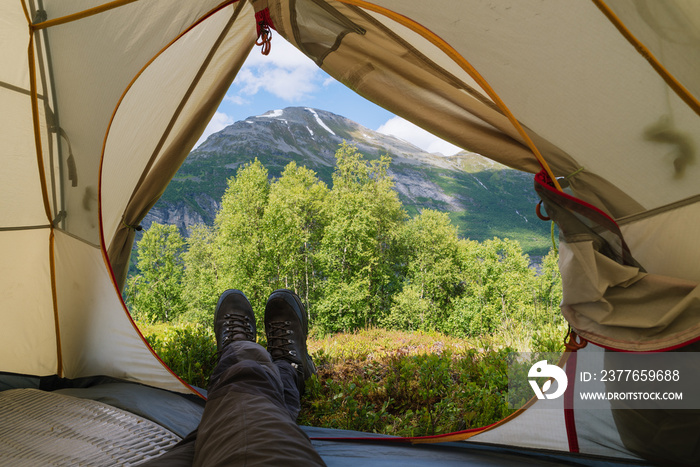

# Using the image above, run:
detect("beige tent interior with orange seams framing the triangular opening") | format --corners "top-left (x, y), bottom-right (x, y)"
top-left (0, 0), bottom-right (700, 465)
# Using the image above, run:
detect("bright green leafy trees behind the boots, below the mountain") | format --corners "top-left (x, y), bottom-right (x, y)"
top-left (127, 144), bottom-right (561, 336)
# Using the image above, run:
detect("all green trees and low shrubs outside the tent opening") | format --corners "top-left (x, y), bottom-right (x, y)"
top-left (124, 144), bottom-right (566, 435)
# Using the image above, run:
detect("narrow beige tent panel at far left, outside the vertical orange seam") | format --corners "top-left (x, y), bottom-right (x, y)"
top-left (0, 2), bottom-right (58, 375)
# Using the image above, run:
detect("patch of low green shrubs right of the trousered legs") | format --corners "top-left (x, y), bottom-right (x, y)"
top-left (299, 330), bottom-right (513, 436)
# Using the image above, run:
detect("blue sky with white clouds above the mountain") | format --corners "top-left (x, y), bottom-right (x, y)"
top-left (197, 32), bottom-right (460, 155)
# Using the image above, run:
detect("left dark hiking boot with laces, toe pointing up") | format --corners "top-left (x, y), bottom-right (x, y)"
top-left (214, 289), bottom-right (255, 354)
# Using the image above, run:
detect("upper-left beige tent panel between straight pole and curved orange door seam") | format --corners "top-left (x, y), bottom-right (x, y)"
top-left (39, 1), bottom-right (246, 249)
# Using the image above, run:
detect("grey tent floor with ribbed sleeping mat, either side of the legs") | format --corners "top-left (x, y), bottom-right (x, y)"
top-left (0, 374), bottom-right (645, 467)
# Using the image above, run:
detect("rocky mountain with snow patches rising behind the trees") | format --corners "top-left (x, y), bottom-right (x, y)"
top-left (142, 107), bottom-right (551, 256)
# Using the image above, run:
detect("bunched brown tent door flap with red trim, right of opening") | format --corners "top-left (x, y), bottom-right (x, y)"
top-left (536, 174), bottom-right (700, 351)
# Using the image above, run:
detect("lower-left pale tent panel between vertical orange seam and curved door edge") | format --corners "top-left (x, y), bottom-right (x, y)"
top-left (56, 232), bottom-right (185, 391)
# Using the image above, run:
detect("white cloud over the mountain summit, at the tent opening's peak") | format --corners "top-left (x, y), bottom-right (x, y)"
top-left (227, 34), bottom-right (323, 102)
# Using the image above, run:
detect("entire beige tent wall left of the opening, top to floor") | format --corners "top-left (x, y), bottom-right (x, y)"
top-left (0, 0), bottom-right (255, 392)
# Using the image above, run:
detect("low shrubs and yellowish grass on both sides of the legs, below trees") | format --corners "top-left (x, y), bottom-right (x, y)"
top-left (142, 323), bottom-right (548, 436)
